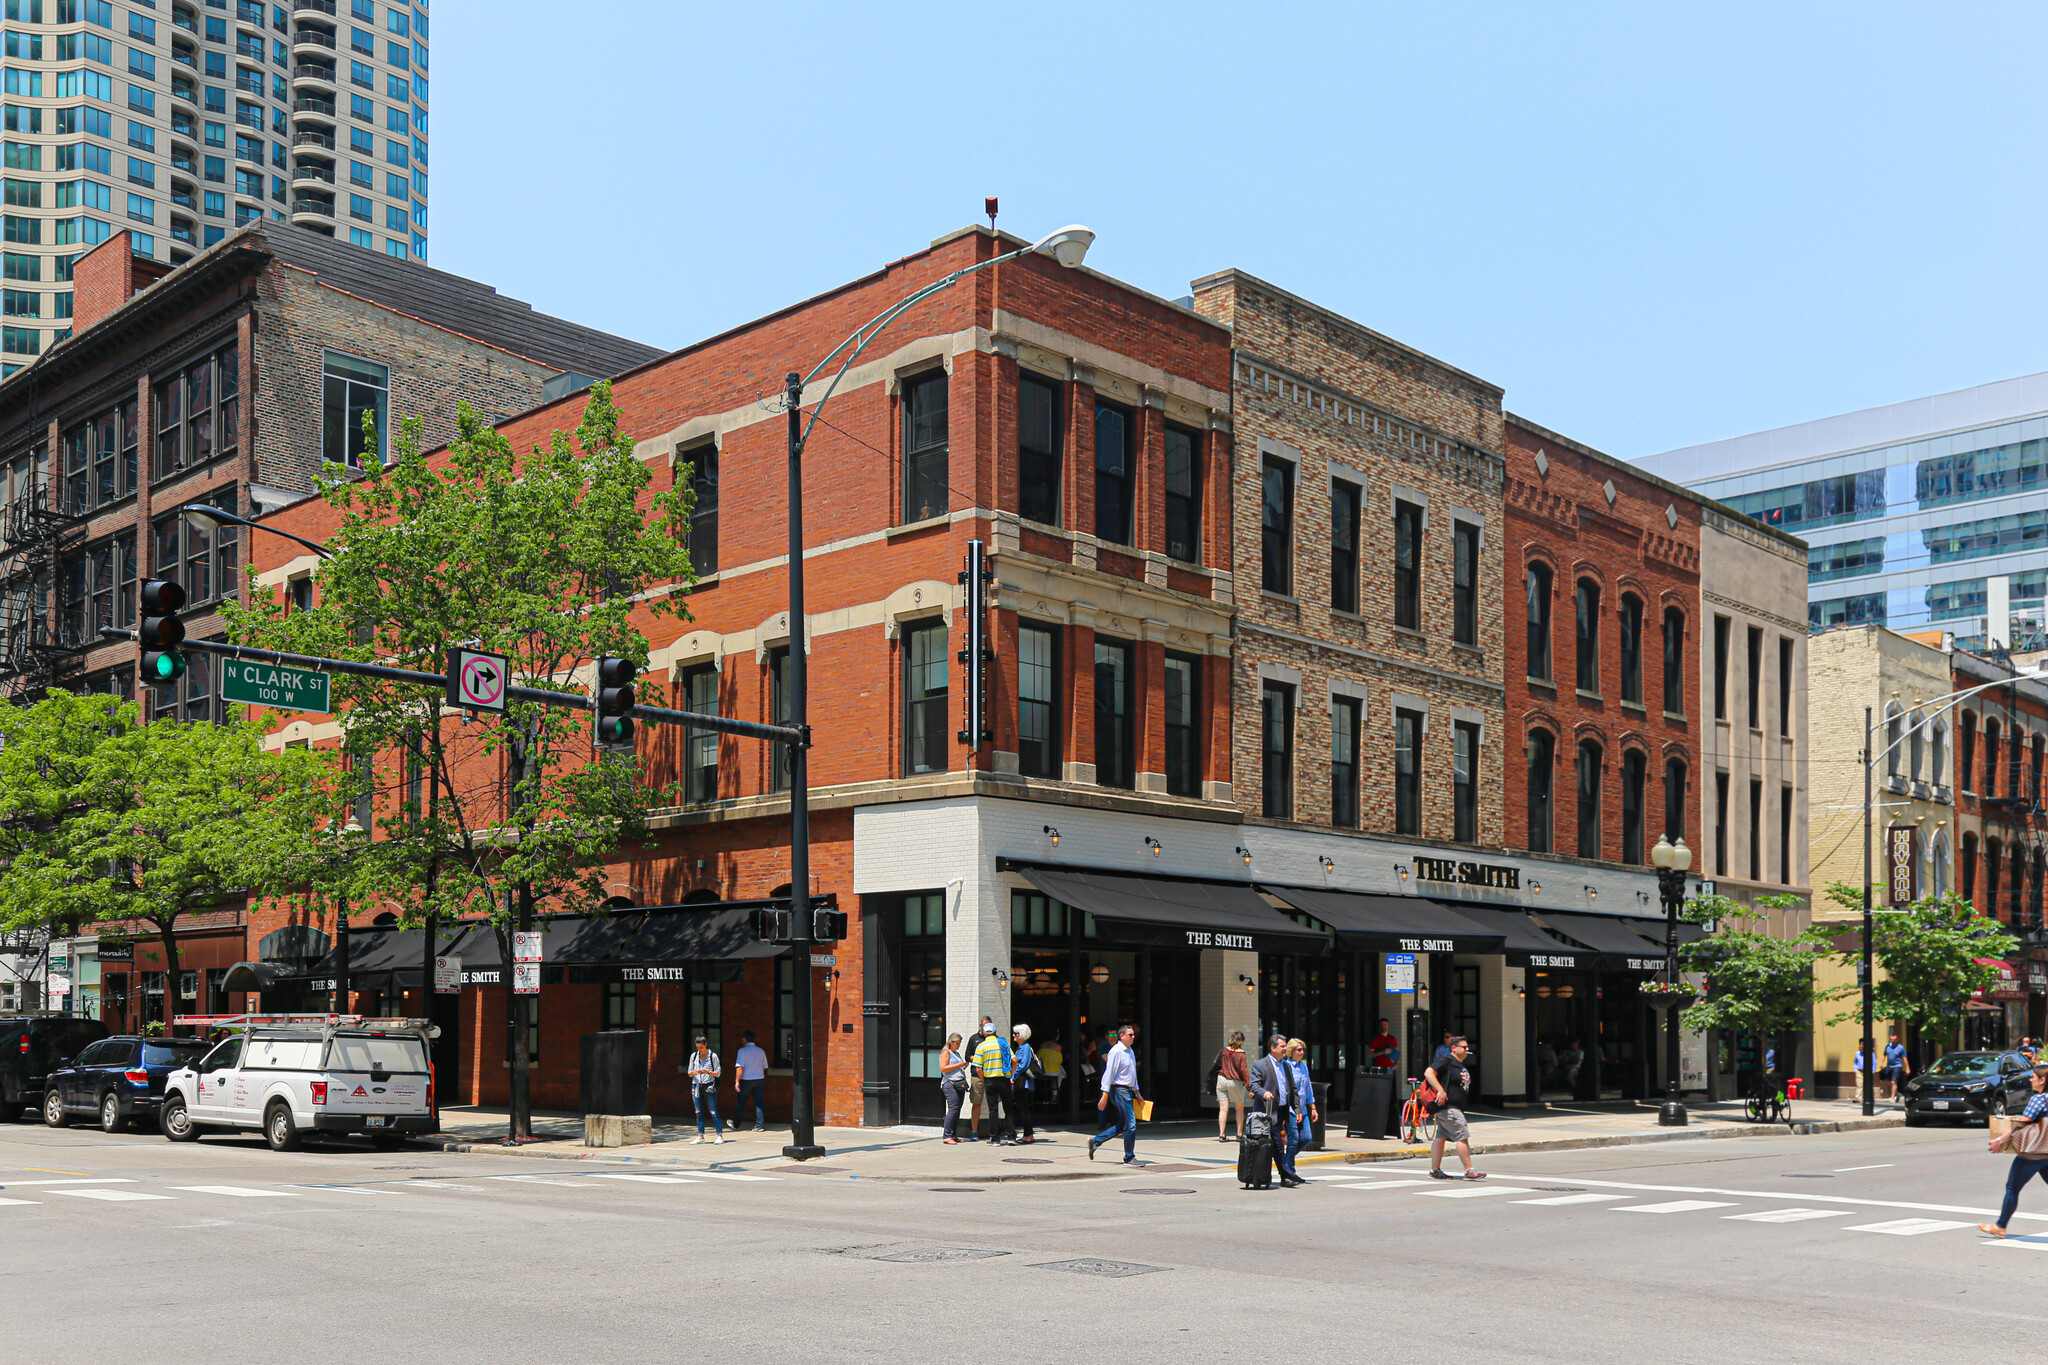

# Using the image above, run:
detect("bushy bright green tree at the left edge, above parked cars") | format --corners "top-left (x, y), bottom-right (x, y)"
top-left (0, 692), bottom-right (326, 1013)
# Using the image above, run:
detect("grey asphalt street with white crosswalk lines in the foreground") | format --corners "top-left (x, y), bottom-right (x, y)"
top-left (0, 1124), bottom-right (2048, 1365)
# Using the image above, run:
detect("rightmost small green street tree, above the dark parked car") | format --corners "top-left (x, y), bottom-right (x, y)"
top-left (1821, 882), bottom-right (2019, 1064)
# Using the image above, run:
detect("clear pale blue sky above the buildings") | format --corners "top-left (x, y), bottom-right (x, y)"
top-left (432, 0), bottom-right (2048, 456)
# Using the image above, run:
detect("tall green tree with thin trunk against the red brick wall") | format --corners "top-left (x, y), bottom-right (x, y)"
top-left (229, 383), bottom-right (696, 1138)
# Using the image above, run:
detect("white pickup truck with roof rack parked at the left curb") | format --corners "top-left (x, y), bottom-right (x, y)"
top-left (160, 1017), bottom-right (438, 1152)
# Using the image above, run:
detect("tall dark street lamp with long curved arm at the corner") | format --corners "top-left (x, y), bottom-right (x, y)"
top-left (782, 223), bottom-right (1096, 1160)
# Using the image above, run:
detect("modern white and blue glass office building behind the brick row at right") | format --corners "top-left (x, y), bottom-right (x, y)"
top-left (1638, 375), bottom-right (2048, 649)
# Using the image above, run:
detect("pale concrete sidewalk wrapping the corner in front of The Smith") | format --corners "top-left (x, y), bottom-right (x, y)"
top-left (418, 1101), bottom-right (1903, 1183)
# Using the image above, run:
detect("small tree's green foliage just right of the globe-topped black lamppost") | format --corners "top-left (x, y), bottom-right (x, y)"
top-left (1679, 896), bottom-right (1821, 1036)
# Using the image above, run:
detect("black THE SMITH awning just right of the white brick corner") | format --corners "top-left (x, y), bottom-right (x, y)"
top-left (1018, 868), bottom-right (1329, 954)
